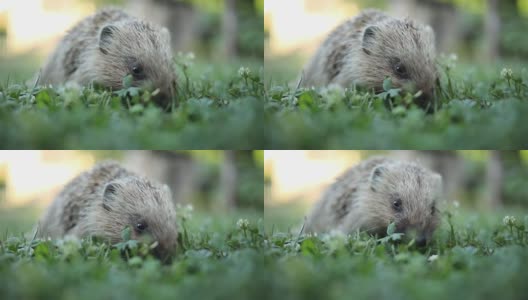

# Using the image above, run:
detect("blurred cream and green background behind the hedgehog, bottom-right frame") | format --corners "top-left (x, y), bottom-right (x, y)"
top-left (264, 150), bottom-right (528, 230)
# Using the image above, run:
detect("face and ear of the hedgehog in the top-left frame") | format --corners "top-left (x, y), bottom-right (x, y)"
top-left (98, 21), bottom-right (176, 108)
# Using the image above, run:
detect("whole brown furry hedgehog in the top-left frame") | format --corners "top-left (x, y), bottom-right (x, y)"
top-left (40, 9), bottom-right (175, 106)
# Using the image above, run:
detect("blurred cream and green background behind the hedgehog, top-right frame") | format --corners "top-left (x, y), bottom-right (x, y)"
top-left (264, 0), bottom-right (528, 84)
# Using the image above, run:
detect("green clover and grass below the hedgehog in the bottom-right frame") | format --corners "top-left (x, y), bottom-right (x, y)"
top-left (265, 204), bottom-right (528, 300)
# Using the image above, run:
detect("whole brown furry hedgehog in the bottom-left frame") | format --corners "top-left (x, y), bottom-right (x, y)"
top-left (37, 162), bottom-right (178, 258)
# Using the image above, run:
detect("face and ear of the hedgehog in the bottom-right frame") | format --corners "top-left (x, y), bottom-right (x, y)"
top-left (368, 163), bottom-right (442, 246)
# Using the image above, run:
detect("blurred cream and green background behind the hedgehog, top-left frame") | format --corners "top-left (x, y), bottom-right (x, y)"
top-left (0, 0), bottom-right (264, 84)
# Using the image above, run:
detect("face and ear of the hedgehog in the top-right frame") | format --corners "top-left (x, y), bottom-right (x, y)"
top-left (361, 19), bottom-right (438, 107)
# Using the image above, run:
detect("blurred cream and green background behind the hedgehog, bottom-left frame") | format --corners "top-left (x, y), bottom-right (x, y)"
top-left (0, 150), bottom-right (264, 234)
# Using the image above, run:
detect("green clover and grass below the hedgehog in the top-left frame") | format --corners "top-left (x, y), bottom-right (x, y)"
top-left (0, 56), bottom-right (264, 149)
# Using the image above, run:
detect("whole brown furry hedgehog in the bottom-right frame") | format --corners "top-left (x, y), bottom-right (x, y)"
top-left (305, 158), bottom-right (442, 246)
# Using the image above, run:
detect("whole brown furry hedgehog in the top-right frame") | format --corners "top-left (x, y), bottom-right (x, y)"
top-left (303, 10), bottom-right (437, 105)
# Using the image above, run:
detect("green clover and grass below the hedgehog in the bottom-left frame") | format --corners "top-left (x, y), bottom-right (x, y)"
top-left (0, 206), bottom-right (265, 300)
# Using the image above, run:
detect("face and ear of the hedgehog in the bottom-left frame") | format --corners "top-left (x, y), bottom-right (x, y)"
top-left (99, 178), bottom-right (178, 261)
